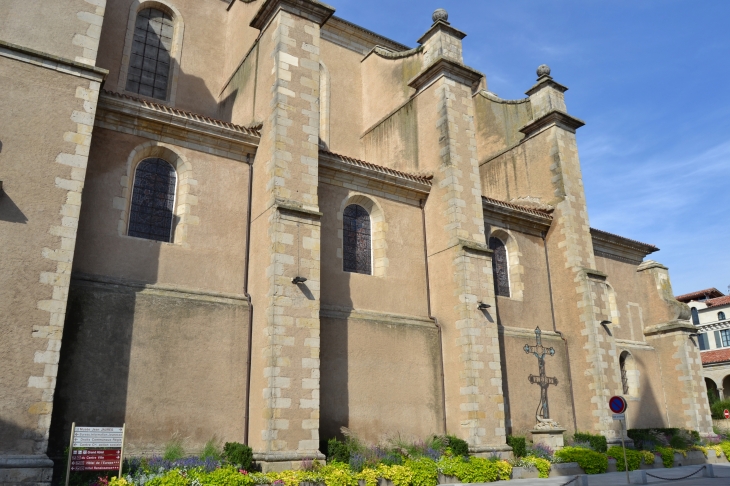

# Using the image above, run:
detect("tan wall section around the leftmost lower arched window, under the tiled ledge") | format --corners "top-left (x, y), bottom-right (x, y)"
top-left (74, 129), bottom-right (249, 293)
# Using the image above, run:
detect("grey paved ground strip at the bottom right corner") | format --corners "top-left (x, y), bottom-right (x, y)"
top-left (500, 464), bottom-right (730, 486)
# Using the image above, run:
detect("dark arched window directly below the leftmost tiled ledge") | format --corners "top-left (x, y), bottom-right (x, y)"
top-left (127, 158), bottom-right (177, 242)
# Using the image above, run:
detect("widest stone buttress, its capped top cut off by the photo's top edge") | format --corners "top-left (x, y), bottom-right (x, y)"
top-left (249, 0), bottom-right (333, 469)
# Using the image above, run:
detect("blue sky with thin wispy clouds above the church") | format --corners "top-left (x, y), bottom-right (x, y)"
top-left (329, 0), bottom-right (730, 294)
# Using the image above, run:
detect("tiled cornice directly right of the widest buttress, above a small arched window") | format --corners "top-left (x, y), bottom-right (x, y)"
top-left (319, 150), bottom-right (431, 195)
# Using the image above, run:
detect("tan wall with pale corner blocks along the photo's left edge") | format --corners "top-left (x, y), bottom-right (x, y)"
top-left (0, 0), bottom-right (106, 470)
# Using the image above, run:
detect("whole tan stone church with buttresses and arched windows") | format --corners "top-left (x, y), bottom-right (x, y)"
top-left (0, 0), bottom-right (711, 484)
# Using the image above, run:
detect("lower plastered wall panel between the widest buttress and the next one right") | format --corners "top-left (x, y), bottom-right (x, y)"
top-left (320, 312), bottom-right (444, 443)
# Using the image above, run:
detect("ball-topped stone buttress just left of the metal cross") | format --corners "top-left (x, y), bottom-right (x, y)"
top-left (409, 16), bottom-right (509, 453)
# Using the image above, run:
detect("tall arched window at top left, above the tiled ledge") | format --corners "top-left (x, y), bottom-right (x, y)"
top-left (126, 8), bottom-right (174, 100)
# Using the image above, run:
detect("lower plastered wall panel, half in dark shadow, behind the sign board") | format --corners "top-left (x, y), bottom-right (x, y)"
top-left (50, 274), bottom-right (248, 457)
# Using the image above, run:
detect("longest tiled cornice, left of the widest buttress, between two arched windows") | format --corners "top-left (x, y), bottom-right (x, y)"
top-left (94, 91), bottom-right (261, 160)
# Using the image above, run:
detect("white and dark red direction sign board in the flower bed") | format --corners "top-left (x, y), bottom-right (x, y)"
top-left (66, 423), bottom-right (125, 486)
